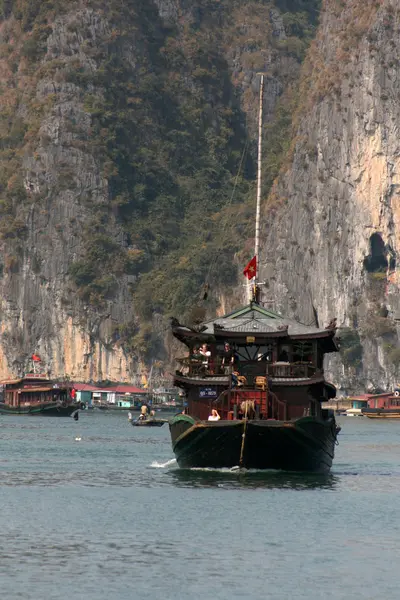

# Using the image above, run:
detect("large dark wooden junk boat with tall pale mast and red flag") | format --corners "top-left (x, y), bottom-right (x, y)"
top-left (169, 76), bottom-right (339, 472)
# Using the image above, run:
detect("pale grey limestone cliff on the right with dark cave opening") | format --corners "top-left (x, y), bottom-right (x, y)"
top-left (262, 0), bottom-right (400, 392)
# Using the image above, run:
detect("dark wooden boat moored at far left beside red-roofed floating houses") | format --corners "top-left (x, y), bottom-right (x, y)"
top-left (0, 373), bottom-right (80, 417)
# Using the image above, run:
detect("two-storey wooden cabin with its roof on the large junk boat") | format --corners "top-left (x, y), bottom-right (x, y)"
top-left (172, 302), bottom-right (338, 420)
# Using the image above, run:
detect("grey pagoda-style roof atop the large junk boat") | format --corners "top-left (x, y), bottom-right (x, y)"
top-left (173, 302), bottom-right (338, 352)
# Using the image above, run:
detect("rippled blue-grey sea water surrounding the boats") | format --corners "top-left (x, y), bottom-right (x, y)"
top-left (0, 411), bottom-right (400, 600)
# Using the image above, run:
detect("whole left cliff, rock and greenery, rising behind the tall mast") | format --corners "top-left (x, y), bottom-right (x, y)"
top-left (0, 0), bottom-right (316, 380)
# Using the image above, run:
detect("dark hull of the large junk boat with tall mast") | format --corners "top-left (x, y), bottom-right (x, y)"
top-left (169, 415), bottom-right (339, 473)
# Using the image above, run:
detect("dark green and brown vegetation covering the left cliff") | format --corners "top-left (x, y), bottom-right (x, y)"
top-left (0, 0), bottom-right (320, 360)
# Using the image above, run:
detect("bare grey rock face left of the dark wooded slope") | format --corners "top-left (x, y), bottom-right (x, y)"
top-left (0, 3), bottom-right (136, 380)
